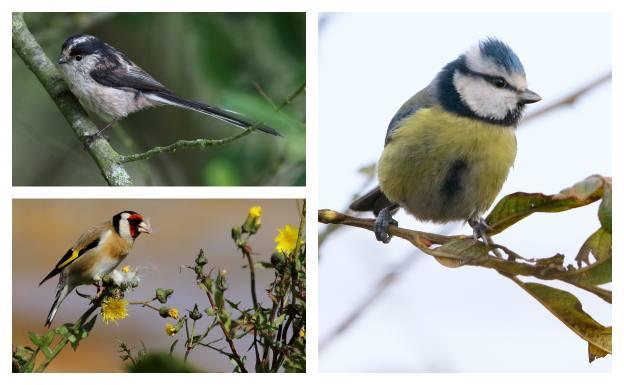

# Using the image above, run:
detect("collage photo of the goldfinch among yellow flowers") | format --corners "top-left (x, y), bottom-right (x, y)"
top-left (12, 199), bottom-right (306, 373)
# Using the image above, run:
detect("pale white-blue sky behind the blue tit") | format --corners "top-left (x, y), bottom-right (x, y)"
top-left (319, 13), bottom-right (611, 372)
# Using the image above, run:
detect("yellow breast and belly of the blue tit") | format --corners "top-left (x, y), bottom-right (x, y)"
top-left (378, 107), bottom-right (516, 222)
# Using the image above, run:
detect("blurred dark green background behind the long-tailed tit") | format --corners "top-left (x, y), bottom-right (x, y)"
top-left (12, 13), bottom-right (306, 186)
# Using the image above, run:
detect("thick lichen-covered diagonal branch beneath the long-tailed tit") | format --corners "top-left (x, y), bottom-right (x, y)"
top-left (13, 13), bottom-right (133, 186)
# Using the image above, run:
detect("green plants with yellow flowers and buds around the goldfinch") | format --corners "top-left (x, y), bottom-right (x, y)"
top-left (12, 201), bottom-right (306, 373)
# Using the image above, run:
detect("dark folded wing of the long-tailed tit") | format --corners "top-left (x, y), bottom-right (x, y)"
top-left (90, 65), bottom-right (171, 93)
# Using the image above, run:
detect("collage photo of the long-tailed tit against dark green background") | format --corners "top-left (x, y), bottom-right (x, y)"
top-left (12, 12), bottom-right (306, 186)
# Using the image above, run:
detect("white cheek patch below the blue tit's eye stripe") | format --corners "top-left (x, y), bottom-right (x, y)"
top-left (453, 72), bottom-right (518, 119)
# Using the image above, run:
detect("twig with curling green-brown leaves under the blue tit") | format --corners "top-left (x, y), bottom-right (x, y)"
top-left (318, 175), bottom-right (612, 362)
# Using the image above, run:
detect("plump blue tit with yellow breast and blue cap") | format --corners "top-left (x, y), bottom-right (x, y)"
top-left (350, 37), bottom-right (542, 244)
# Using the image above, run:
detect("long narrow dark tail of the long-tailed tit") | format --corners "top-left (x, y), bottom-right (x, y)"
top-left (145, 92), bottom-right (281, 136)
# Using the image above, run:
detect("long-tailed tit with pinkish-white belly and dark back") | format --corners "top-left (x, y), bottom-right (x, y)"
top-left (58, 34), bottom-right (281, 136)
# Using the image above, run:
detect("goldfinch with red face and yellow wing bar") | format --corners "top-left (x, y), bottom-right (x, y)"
top-left (39, 210), bottom-right (151, 327)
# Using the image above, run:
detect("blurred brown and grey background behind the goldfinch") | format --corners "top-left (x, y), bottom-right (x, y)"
top-left (13, 199), bottom-right (301, 372)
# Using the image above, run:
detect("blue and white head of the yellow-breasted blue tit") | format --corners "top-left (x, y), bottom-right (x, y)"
top-left (437, 38), bottom-right (541, 126)
